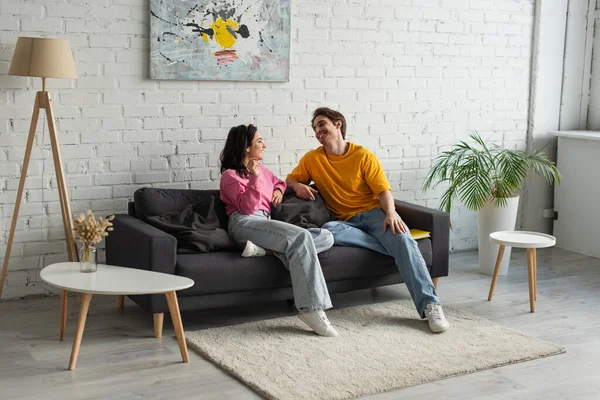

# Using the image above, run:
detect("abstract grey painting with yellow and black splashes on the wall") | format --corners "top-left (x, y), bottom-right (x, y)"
top-left (150, 0), bottom-right (291, 82)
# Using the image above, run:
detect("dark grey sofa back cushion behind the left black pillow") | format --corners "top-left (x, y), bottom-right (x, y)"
top-left (133, 188), bottom-right (229, 230)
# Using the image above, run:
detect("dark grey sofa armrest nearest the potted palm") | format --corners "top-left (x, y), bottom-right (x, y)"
top-left (395, 200), bottom-right (450, 278)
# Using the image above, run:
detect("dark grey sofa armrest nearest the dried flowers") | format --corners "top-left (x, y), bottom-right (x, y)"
top-left (106, 214), bottom-right (177, 274)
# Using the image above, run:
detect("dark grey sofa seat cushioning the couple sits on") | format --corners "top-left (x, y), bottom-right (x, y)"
top-left (175, 239), bottom-right (432, 296)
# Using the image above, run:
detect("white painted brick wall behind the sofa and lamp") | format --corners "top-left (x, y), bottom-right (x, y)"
top-left (0, 0), bottom-right (533, 297)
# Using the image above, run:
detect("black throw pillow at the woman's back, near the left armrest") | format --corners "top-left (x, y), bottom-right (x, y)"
top-left (146, 196), bottom-right (239, 254)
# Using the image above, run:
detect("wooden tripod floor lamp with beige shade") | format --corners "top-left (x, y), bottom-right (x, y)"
top-left (0, 37), bottom-right (79, 340)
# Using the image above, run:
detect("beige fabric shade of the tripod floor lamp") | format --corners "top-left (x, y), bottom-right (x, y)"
top-left (8, 37), bottom-right (77, 79)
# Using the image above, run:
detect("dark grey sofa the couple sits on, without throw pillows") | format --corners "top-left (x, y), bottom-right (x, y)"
top-left (106, 188), bottom-right (450, 332)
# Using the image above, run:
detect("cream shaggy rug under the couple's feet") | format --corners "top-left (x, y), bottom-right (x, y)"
top-left (186, 300), bottom-right (565, 400)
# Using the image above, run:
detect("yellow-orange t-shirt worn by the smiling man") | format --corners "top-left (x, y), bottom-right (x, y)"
top-left (287, 143), bottom-right (391, 221)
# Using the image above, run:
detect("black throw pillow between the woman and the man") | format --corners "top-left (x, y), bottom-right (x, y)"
top-left (271, 189), bottom-right (335, 229)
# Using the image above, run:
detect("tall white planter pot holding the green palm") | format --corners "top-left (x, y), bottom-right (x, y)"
top-left (477, 196), bottom-right (519, 275)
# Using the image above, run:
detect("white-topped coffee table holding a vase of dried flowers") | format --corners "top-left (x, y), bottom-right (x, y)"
top-left (40, 262), bottom-right (194, 370)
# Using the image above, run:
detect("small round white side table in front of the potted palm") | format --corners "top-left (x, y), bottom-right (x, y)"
top-left (488, 231), bottom-right (556, 312)
